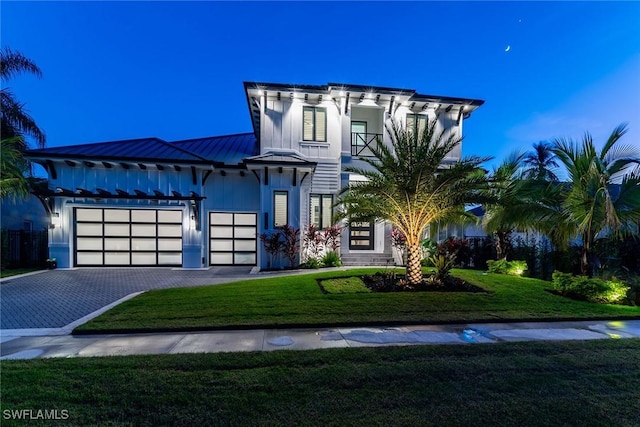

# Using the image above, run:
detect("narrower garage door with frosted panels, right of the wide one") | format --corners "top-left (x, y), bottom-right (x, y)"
top-left (209, 212), bottom-right (258, 265)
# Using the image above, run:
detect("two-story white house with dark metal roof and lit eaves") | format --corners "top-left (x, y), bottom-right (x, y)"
top-left (27, 82), bottom-right (483, 268)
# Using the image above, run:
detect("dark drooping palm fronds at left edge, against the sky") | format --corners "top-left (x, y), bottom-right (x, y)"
top-left (0, 47), bottom-right (46, 150)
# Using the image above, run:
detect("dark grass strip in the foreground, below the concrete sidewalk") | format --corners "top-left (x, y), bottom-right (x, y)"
top-left (0, 339), bottom-right (640, 426)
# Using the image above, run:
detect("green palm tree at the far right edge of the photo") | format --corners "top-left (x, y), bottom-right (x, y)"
top-left (553, 124), bottom-right (640, 276)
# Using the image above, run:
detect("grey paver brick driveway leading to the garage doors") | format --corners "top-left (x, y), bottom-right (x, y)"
top-left (0, 267), bottom-right (256, 329)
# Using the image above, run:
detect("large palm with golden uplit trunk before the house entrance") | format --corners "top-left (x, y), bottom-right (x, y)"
top-left (337, 120), bottom-right (489, 287)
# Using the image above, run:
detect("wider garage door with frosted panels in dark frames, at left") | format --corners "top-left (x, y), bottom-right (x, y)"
top-left (75, 208), bottom-right (182, 266)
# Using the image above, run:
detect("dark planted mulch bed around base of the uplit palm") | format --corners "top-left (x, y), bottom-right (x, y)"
top-left (362, 273), bottom-right (487, 292)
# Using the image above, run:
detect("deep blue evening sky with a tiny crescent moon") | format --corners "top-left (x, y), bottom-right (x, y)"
top-left (0, 1), bottom-right (640, 172)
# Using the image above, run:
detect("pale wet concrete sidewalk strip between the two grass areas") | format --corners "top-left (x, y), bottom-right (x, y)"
top-left (0, 320), bottom-right (640, 360)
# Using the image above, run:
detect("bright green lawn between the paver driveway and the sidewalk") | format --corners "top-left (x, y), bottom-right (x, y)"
top-left (75, 269), bottom-right (640, 333)
